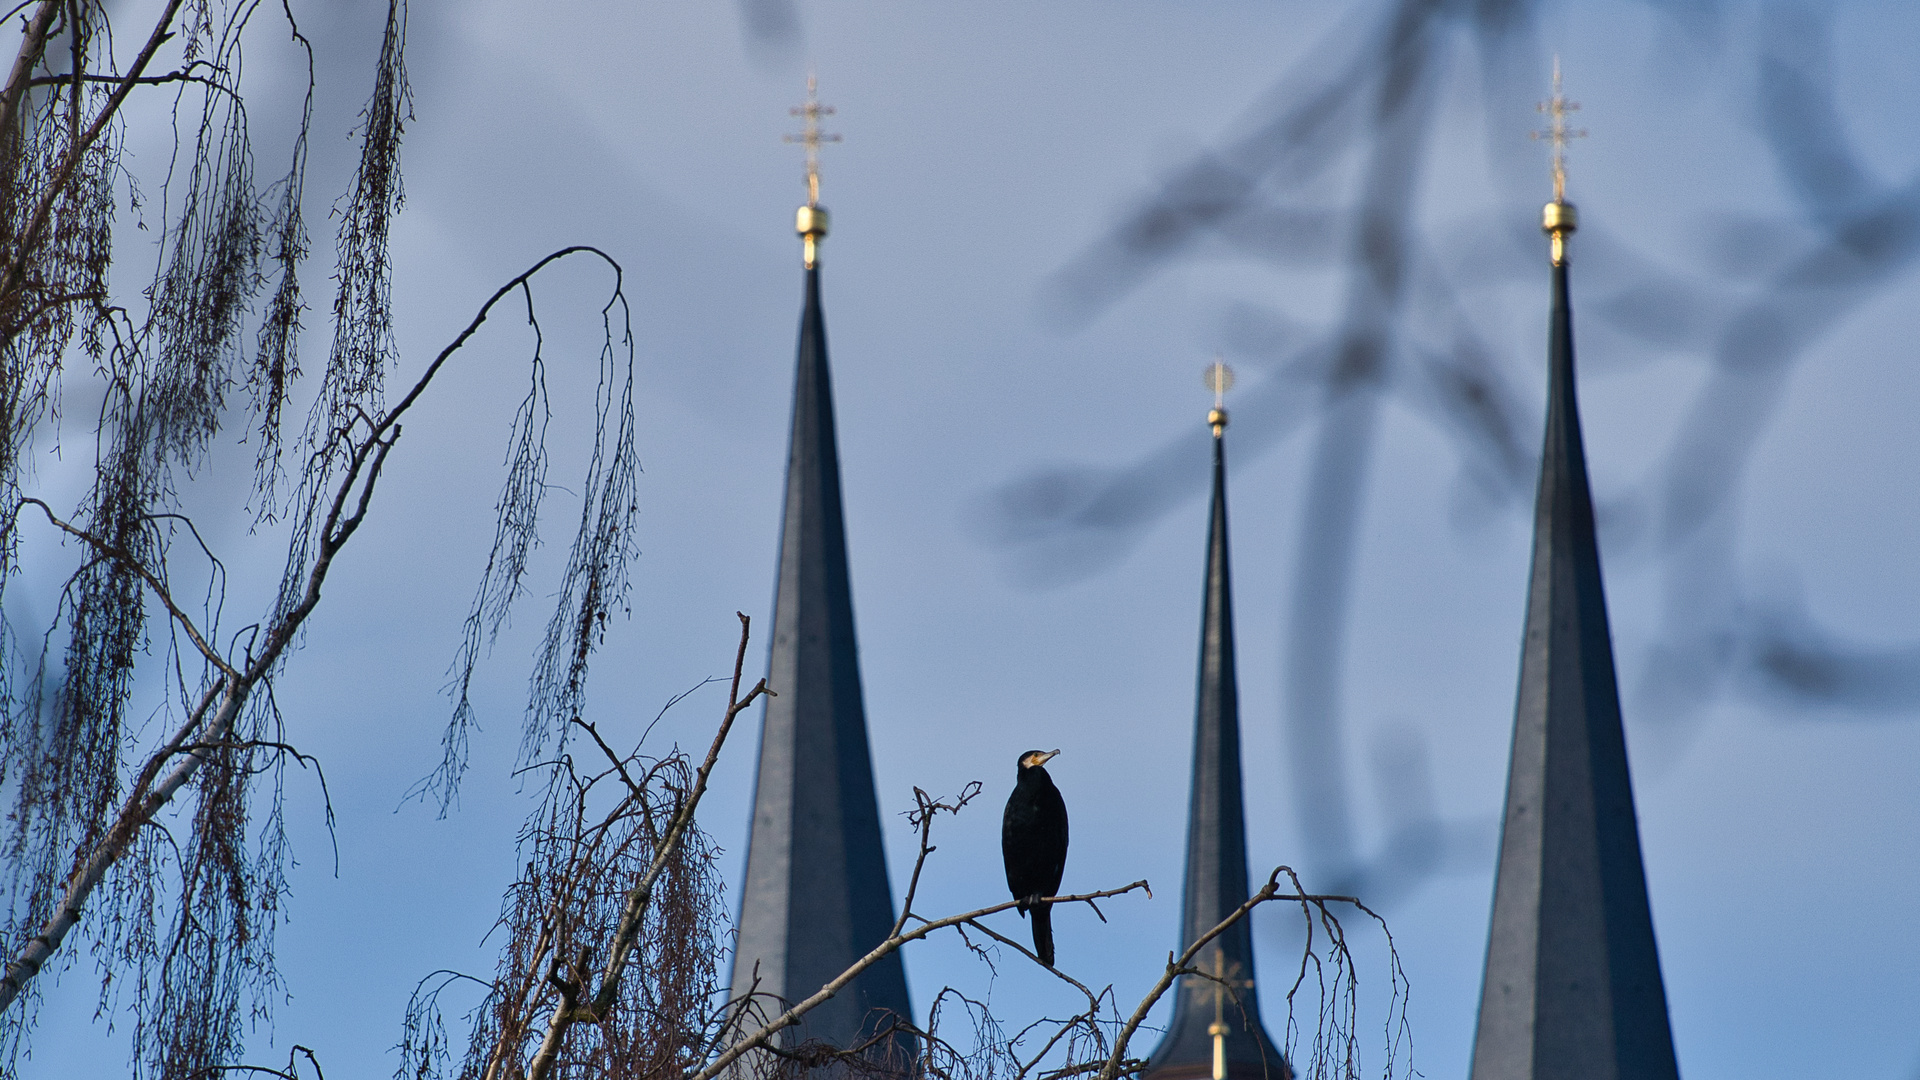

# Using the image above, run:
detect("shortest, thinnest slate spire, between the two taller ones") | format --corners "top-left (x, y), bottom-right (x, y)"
top-left (1142, 365), bottom-right (1290, 1080)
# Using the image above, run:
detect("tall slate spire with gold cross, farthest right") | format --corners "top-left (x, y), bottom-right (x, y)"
top-left (1473, 69), bottom-right (1678, 1080)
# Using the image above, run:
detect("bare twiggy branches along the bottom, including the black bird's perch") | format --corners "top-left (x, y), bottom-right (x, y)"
top-left (397, 638), bottom-right (1411, 1080)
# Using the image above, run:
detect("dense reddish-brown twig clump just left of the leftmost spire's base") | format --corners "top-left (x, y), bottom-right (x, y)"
top-left (399, 615), bottom-right (770, 1080)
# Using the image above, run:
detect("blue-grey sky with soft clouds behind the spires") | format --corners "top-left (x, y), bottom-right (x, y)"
top-left (8, 0), bottom-right (1920, 1080)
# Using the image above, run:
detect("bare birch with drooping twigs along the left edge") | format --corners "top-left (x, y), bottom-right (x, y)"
top-left (0, 0), bottom-right (637, 1080)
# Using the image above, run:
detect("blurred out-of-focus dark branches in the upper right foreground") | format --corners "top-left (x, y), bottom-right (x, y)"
top-left (970, 0), bottom-right (1920, 896)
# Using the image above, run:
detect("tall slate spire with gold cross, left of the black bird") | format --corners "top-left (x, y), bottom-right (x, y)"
top-left (732, 83), bottom-right (912, 1057)
